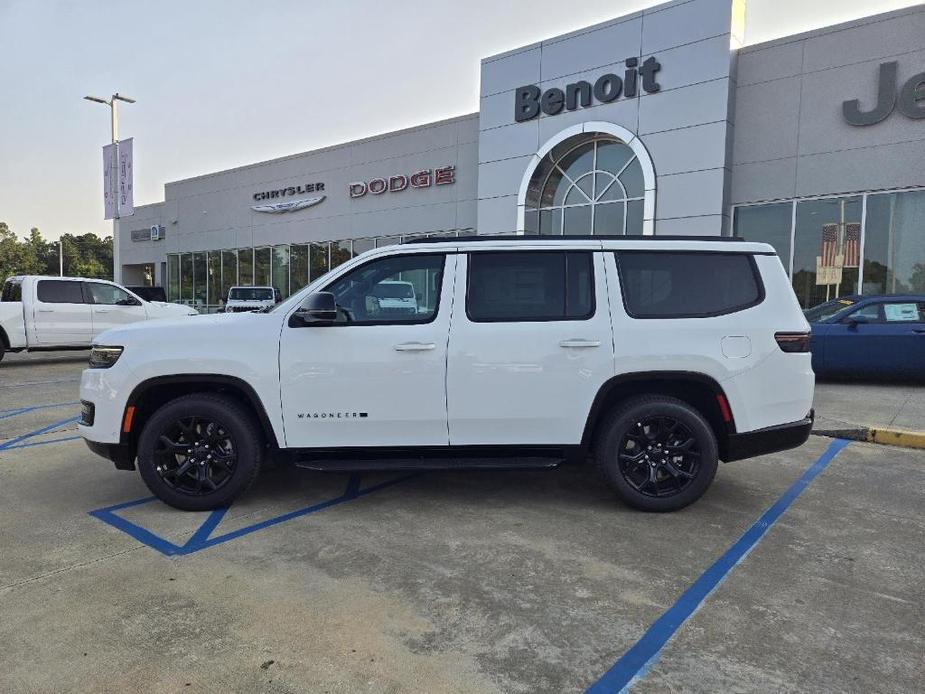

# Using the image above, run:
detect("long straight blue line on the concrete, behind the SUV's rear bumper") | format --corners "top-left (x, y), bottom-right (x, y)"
top-left (587, 439), bottom-right (851, 694)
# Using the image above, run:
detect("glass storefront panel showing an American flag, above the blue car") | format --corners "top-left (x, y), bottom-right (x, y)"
top-left (792, 196), bottom-right (861, 308)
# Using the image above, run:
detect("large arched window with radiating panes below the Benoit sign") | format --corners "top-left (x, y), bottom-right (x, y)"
top-left (524, 133), bottom-right (646, 235)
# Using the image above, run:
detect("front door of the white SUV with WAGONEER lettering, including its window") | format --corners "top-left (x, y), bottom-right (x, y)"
top-left (279, 252), bottom-right (456, 448)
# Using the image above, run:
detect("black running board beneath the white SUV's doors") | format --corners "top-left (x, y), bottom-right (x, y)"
top-left (293, 457), bottom-right (565, 472)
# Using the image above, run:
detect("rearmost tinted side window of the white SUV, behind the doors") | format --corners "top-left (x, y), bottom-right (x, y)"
top-left (616, 251), bottom-right (764, 318)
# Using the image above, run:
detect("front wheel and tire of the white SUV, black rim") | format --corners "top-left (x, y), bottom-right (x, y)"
top-left (138, 393), bottom-right (263, 511)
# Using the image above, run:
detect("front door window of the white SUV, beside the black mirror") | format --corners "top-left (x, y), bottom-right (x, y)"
top-left (324, 254), bottom-right (446, 325)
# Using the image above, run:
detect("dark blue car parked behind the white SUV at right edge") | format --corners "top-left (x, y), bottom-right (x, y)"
top-left (804, 294), bottom-right (925, 379)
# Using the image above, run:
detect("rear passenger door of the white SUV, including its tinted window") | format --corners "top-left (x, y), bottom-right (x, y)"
top-left (447, 248), bottom-right (613, 446)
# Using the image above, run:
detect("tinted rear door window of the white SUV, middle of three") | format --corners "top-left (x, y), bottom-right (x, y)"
top-left (466, 251), bottom-right (594, 323)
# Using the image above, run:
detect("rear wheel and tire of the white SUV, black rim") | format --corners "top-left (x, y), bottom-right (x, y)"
top-left (595, 395), bottom-right (718, 512)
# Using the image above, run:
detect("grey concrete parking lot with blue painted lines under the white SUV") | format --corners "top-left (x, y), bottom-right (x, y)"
top-left (0, 353), bottom-right (925, 692)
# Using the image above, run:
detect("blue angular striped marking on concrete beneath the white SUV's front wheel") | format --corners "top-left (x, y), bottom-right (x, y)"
top-left (89, 472), bottom-right (420, 556)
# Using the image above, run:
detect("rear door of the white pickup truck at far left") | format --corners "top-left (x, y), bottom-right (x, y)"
top-left (32, 279), bottom-right (92, 347)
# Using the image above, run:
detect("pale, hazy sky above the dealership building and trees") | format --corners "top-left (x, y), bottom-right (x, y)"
top-left (0, 0), bottom-right (916, 239)
